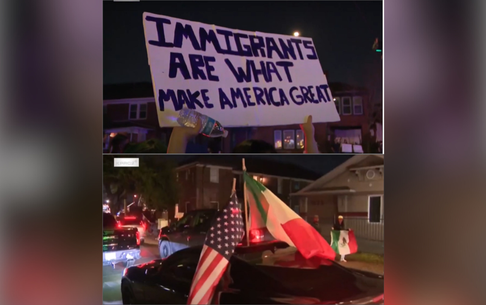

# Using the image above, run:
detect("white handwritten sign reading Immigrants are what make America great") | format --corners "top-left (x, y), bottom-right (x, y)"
top-left (143, 13), bottom-right (339, 127)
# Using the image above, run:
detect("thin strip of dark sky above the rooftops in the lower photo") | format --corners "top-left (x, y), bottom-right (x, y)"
top-left (146, 154), bottom-right (351, 175)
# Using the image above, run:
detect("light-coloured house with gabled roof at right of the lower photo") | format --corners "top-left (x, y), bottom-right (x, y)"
top-left (291, 155), bottom-right (385, 241)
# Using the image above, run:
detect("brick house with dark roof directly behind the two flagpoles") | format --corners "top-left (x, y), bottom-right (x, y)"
top-left (169, 155), bottom-right (319, 216)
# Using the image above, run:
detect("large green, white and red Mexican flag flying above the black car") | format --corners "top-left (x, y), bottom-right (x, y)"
top-left (243, 172), bottom-right (336, 260)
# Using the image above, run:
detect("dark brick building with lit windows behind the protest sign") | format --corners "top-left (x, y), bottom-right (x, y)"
top-left (103, 83), bottom-right (376, 153)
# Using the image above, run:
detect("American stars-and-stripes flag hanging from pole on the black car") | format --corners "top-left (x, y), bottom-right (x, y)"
top-left (187, 194), bottom-right (244, 304)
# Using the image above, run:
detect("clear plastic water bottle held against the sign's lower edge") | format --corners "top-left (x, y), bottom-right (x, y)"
top-left (177, 108), bottom-right (228, 138)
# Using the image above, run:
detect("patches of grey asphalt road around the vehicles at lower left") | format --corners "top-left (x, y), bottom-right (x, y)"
top-left (103, 243), bottom-right (160, 305)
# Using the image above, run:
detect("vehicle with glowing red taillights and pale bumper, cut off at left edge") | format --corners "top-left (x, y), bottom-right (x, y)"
top-left (103, 213), bottom-right (140, 266)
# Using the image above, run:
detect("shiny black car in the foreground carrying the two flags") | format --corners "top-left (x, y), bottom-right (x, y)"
top-left (121, 242), bottom-right (384, 305)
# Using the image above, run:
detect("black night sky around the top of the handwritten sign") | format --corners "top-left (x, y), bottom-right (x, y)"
top-left (103, 1), bottom-right (383, 93)
